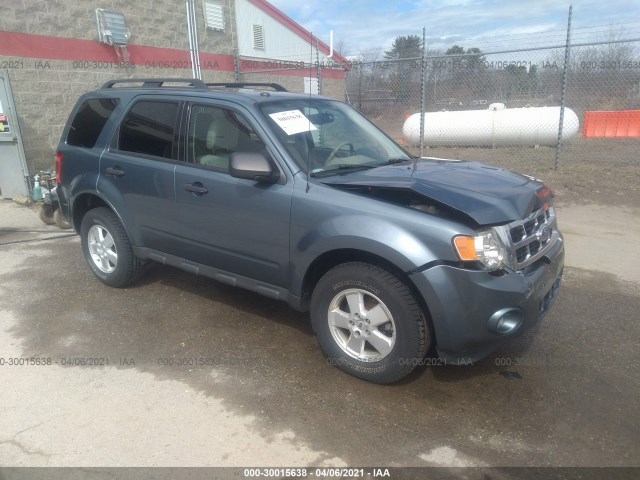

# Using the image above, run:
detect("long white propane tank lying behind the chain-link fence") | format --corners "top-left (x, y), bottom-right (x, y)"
top-left (402, 103), bottom-right (580, 146)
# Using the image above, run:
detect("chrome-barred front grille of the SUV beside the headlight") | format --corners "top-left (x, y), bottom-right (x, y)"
top-left (507, 207), bottom-right (558, 270)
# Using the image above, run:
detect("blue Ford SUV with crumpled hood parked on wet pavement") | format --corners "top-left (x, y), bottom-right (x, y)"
top-left (56, 79), bottom-right (564, 383)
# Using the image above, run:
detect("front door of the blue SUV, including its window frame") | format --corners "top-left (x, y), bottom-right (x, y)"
top-left (176, 100), bottom-right (293, 286)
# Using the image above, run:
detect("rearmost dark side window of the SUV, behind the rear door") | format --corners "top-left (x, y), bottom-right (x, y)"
top-left (67, 98), bottom-right (118, 148)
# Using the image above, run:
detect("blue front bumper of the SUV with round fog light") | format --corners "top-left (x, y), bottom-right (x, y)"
top-left (410, 235), bottom-right (564, 364)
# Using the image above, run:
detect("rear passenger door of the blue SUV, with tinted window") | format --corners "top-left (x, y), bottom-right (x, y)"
top-left (98, 96), bottom-right (182, 255)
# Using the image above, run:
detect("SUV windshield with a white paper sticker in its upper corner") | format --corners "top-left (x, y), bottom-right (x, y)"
top-left (260, 99), bottom-right (411, 176)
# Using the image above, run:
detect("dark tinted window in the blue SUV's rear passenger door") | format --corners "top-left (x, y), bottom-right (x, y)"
top-left (118, 100), bottom-right (178, 159)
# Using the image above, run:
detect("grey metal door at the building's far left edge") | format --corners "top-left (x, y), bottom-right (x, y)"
top-left (0, 69), bottom-right (29, 198)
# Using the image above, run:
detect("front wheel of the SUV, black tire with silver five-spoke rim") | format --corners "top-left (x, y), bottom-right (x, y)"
top-left (311, 262), bottom-right (431, 383)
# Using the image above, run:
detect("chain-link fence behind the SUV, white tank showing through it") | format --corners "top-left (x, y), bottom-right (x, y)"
top-left (236, 24), bottom-right (640, 199)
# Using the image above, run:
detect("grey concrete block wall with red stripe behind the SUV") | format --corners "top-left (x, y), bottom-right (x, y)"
top-left (0, 0), bottom-right (344, 173)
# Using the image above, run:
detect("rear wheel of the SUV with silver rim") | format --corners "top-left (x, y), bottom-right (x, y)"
top-left (80, 207), bottom-right (142, 287)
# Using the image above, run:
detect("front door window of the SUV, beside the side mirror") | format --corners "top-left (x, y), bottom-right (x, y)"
top-left (187, 105), bottom-right (266, 173)
